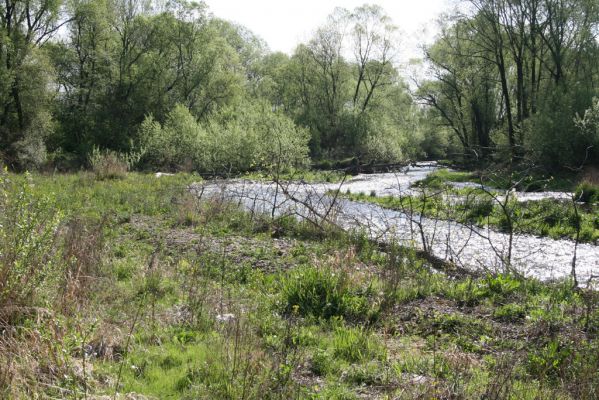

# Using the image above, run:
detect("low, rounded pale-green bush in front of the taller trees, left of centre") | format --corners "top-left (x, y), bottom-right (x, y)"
top-left (138, 104), bottom-right (309, 174)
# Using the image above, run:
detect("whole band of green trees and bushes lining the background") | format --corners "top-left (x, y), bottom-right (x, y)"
top-left (0, 0), bottom-right (599, 172)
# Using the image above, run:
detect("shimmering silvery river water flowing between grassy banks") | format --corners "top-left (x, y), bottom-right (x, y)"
top-left (192, 163), bottom-right (599, 284)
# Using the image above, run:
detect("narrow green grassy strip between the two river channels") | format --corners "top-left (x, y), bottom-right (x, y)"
top-left (339, 169), bottom-right (599, 243)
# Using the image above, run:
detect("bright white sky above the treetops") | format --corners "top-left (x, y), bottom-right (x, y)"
top-left (205, 0), bottom-right (450, 64)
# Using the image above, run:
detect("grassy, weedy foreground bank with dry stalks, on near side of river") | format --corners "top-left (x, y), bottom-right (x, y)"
top-left (0, 172), bottom-right (599, 399)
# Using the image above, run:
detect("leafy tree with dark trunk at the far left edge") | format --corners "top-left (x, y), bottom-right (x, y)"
top-left (0, 0), bottom-right (65, 166)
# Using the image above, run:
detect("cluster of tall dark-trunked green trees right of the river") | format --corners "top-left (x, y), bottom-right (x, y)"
top-left (417, 0), bottom-right (599, 170)
